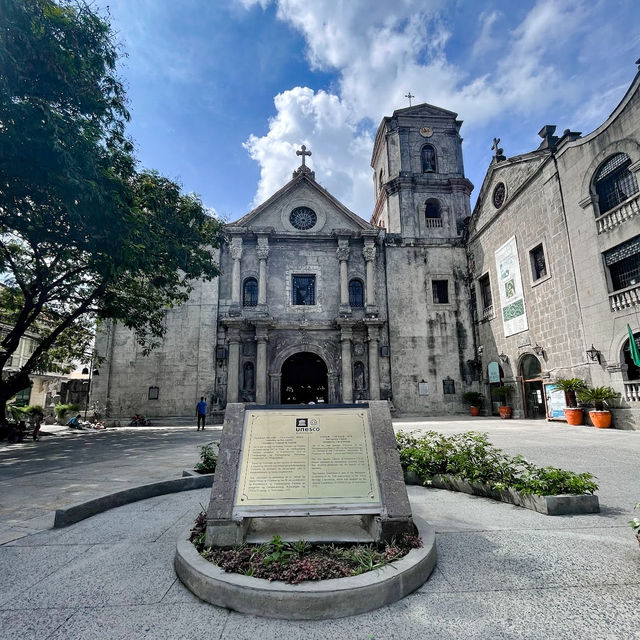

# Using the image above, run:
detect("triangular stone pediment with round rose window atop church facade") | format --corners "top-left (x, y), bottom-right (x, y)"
top-left (227, 172), bottom-right (377, 236)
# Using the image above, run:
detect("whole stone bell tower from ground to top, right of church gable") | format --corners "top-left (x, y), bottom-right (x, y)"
top-left (371, 98), bottom-right (477, 415)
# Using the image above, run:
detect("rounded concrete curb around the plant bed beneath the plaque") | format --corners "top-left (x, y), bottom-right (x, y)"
top-left (174, 516), bottom-right (436, 620)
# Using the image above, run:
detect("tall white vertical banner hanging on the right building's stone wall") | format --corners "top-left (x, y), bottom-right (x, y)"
top-left (496, 236), bottom-right (529, 337)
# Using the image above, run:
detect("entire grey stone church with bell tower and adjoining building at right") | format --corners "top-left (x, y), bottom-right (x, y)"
top-left (92, 65), bottom-right (640, 428)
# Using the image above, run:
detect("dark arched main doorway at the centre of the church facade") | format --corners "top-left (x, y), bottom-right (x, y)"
top-left (280, 352), bottom-right (329, 404)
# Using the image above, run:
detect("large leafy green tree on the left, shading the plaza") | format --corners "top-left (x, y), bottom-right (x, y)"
top-left (0, 0), bottom-right (222, 419)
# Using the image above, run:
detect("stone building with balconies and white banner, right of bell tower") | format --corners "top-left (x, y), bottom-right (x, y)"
top-left (467, 67), bottom-right (640, 428)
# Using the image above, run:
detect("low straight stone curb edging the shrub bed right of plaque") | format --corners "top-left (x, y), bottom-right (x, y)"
top-left (405, 472), bottom-right (600, 516)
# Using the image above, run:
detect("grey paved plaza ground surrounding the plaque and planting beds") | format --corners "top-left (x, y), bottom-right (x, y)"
top-left (0, 418), bottom-right (640, 640)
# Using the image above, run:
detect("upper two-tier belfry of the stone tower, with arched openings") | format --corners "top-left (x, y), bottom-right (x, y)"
top-left (371, 103), bottom-right (473, 242)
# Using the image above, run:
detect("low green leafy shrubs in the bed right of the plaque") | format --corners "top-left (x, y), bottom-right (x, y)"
top-left (397, 431), bottom-right (598, 495)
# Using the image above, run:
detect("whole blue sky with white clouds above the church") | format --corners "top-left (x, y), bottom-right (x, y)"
top-left (98, 0), bottom-right (640, 220)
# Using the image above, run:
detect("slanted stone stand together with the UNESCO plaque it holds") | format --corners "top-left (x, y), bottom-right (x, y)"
top-left (206, 401), bottom-right (415, 546)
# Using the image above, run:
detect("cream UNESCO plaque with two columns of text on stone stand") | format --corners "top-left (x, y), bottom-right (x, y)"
top-left (235, 407), bottom-right (380, 508)
